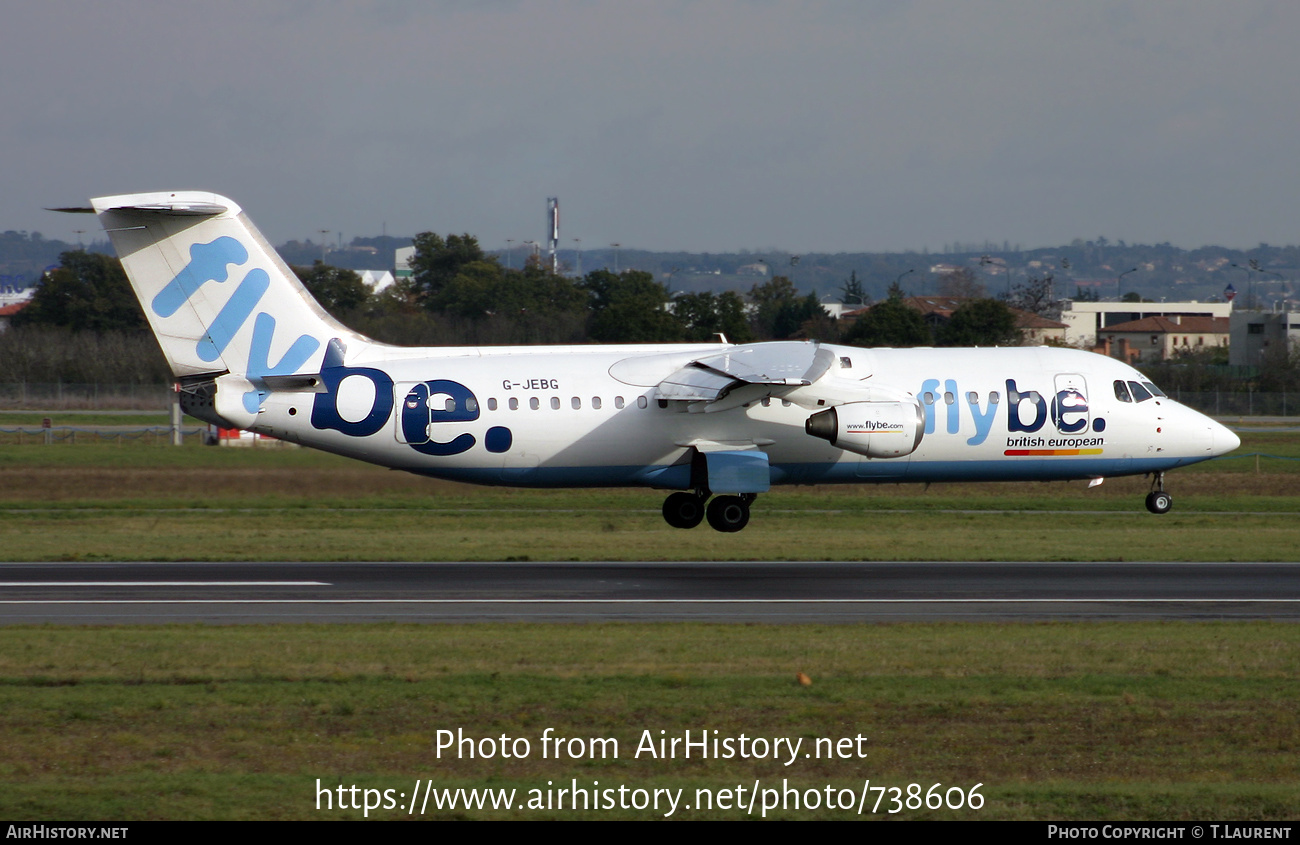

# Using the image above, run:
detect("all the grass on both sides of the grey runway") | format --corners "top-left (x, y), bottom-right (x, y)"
top-left (0, 423), bottom-right (1300, 820)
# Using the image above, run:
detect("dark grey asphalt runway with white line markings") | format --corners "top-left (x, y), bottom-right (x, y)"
top-left (0, 562), bottom-right (1300, 624)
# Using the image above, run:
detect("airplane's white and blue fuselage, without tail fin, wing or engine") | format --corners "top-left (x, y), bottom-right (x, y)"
top-left (254, 345), bottom-right (1239, 489)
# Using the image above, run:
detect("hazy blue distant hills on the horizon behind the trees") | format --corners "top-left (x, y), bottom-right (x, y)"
top-left (0, 224), bottom-right (1300, 307)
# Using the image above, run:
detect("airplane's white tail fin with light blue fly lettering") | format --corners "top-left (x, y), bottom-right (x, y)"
top-left (91, 191), bottom-right (364, 428)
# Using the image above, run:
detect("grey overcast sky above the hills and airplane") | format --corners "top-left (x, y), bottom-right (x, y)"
top-left (0, 0), bottom-right (1300, 252)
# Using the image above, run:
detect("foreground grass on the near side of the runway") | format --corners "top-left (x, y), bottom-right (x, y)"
top-left (0, 623), bottom-right (1300, 819)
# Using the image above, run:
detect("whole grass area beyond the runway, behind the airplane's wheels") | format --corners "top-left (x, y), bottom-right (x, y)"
top-left (0, 421), bottom-right (1300, 560)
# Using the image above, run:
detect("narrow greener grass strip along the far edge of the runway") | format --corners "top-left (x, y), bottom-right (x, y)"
top-left (0, 497), bottom-right (1300, 560)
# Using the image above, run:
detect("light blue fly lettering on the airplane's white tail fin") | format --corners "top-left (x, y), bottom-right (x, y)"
top-left (158, 235), bottom-right (321, 412)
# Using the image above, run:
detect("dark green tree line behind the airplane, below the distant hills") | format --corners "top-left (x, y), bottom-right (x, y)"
top-left (0, 233), bottom-right (1277, 384)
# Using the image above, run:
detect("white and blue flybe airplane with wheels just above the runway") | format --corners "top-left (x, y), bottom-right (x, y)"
top-left (59, 191), bottom-right (1240, 532)
